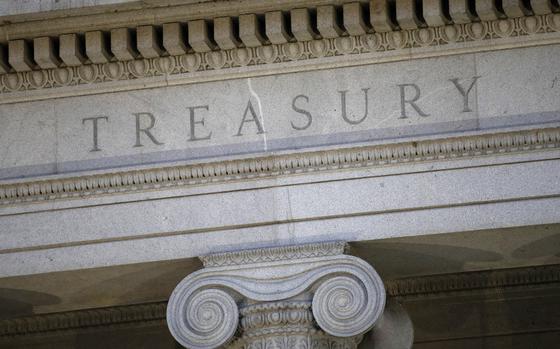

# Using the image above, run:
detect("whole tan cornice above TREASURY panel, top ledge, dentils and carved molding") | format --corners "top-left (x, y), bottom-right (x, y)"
top-left (0, 0), bottom-right (560, 103)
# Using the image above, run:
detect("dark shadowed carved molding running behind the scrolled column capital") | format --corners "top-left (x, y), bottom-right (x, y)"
top-left (0, 265), bottom-right (560, 338)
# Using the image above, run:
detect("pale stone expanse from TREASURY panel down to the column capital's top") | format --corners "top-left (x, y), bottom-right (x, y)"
top-left (0, 45), bottom-right (560, 275)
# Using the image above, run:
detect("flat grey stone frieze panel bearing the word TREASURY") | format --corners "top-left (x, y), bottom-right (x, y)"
top-left (0, 45), bottom-right (560, 179)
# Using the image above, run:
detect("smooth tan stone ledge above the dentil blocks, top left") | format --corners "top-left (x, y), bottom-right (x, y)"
top-left (0, 0), bottom-right (356, 37)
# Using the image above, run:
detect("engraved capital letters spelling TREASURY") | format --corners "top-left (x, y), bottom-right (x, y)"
top-left (82, 76), bottom-right (480, 152)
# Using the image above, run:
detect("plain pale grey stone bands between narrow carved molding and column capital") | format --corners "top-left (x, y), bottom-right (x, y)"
top-left (0, 152), bottom-right (560, 276)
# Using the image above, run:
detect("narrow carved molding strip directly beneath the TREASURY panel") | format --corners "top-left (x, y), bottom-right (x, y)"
top-left (0, 128), bottom-right (560, 205)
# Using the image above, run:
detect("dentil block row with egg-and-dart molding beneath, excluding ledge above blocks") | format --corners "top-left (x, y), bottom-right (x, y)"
top-left (0, 0), bottom-right (560, 104)
